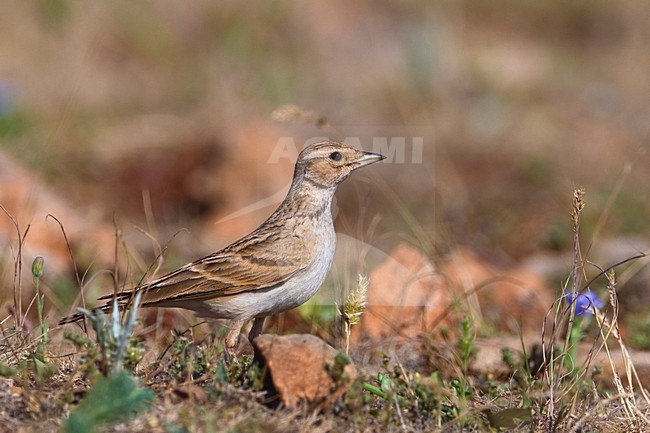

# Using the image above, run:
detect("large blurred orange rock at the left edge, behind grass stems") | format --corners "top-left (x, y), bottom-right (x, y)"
top-left (0, 153), bottom-right (115, 324)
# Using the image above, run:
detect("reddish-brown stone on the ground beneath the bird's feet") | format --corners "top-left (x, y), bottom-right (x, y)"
top-left (253, 334), bottom-right (357, 410)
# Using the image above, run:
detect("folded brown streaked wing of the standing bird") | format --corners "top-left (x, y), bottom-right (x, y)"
top-left (100, 231), bottom-right (311, 306)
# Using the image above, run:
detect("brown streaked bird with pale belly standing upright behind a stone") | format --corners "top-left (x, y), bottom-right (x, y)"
top-left (59, 140), bottom-right (385, 356)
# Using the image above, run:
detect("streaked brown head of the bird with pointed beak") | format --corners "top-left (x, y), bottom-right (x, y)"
top-left (294, 140), bottom-right (385, 189)
